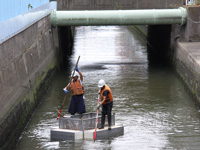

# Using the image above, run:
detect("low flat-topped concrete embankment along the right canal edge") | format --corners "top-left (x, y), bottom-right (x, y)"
top-left (173, 42), bottom-right (200, 106)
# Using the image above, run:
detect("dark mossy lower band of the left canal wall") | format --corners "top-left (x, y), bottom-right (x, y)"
top-left (0, 60), bottom-right (58, 149)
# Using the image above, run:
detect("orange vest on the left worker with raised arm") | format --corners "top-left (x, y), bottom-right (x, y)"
top-left (71, 79), bottom-right (84, 96)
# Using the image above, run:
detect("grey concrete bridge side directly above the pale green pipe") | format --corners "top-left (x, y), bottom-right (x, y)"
top-left (58, 0), bottom-right (185, 10)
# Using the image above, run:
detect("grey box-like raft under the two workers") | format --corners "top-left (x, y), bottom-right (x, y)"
top-left (50, 112), bottom-right (124, 141)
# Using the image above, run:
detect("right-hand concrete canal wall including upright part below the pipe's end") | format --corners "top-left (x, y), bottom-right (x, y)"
top-left (171, 6), bottom-right (200, 106)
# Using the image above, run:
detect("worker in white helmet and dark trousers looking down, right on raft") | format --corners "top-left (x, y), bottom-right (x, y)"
top-left (97, 79), bottom-right (113, 130)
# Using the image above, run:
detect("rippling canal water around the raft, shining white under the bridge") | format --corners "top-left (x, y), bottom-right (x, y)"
top-left (17, 26), bottom-right (200, 150)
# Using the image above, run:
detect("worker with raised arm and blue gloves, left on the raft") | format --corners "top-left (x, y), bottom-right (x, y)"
top-left (63, 67), bottom-right (86, 118)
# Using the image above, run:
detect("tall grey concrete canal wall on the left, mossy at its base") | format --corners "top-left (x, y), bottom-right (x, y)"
top-left (0, 15), bottom-right (58, 149)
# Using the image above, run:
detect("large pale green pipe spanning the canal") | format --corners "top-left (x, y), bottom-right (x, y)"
top-left (51, 7), bottom-right (187, 27)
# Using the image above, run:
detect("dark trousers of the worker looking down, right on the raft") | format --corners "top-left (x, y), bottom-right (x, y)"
top-left (101, 102), bottom-right (113, 127)
